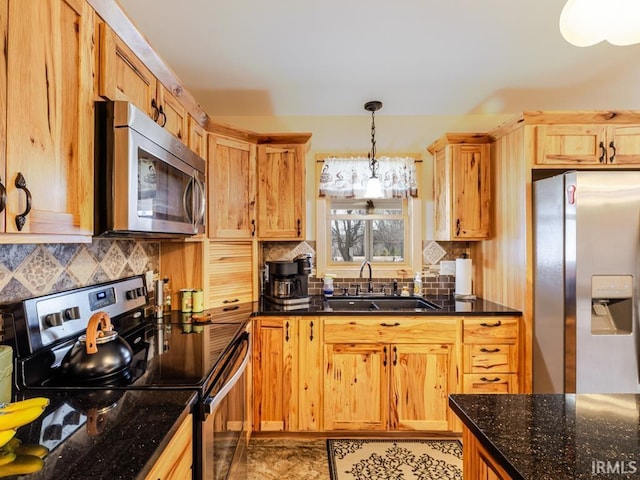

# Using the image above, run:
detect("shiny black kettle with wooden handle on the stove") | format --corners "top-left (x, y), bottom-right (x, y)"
top-left (60, 312), bottom-right (133, 381)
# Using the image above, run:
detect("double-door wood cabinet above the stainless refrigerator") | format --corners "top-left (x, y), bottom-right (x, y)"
top-left (535, 124), bottom-right (640, 168)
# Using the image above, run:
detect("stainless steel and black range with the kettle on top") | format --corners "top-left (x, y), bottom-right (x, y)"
top-left (0, 276), bottom-right (251, 480)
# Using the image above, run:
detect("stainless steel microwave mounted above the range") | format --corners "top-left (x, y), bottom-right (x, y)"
top-left (94, 101), bottom-right (206, 238)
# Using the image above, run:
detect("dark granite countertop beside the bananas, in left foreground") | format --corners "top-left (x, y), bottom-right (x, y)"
top-left (7, 390), bottom-right (195, 480)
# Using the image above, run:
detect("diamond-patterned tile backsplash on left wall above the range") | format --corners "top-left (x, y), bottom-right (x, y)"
top-left (0, 239), bottom-right (160, 303)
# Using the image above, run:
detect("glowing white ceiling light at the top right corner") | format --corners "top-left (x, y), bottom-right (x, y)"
top-left (560, 0), bottom-right (640, 47)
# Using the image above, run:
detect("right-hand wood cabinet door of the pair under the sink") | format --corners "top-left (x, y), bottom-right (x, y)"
top-left (391, 344), bottom-right (456, 430)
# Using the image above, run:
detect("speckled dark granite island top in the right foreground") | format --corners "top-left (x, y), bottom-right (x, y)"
top-left (449, 394), bottom-right (640, 480)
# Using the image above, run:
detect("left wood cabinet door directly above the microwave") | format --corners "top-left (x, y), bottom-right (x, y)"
top-left (98, 24), bottom-right (159, 120)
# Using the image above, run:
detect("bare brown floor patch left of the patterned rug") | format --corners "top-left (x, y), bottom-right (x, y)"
top-left (247, 438), bottom-right (329, 480)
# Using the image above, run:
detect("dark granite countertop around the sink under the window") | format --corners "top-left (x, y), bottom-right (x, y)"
top-left (253, 295), bottom-right (522, 316)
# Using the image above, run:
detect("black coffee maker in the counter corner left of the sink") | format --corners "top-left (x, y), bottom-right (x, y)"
top-left (265, 254), bottom-right (311, 309)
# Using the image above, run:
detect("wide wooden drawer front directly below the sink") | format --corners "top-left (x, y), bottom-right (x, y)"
top-left (324, 316), bottom-right (458, 343)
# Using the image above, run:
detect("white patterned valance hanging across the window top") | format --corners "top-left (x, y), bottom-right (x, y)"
top-left (319, 157), bottom-right (418, 198)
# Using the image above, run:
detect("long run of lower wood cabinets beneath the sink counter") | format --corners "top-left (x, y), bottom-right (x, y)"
top-left (253, 315), bottom-right (521, 432)
